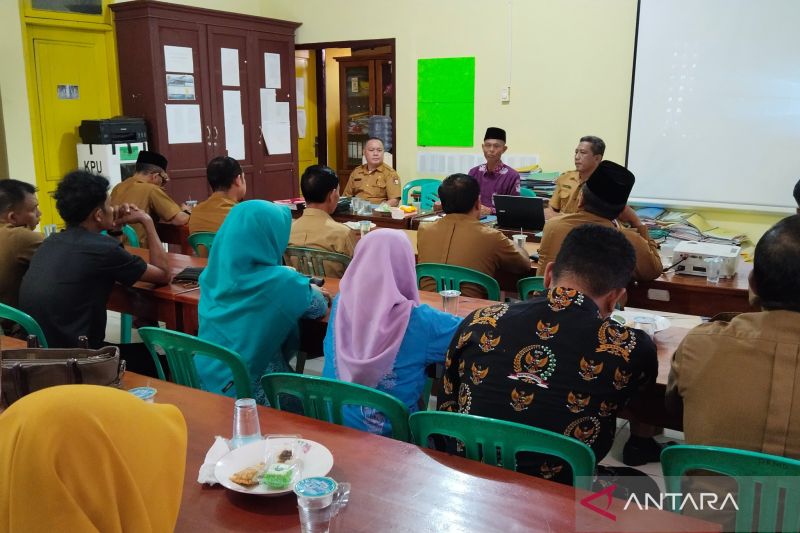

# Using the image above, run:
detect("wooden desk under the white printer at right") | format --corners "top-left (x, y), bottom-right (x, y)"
top-left (628, 260), bottom-right (758, 316)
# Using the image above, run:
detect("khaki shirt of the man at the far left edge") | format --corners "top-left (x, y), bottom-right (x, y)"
top-left (0, 224), bottom-right (44, 307)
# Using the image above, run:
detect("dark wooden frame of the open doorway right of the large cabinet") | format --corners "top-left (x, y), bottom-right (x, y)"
top-left (294, 38), bottom-right (397, 172)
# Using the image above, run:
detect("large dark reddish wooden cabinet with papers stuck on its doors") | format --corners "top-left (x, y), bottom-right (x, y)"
top-left (109, 0), bottom-right (299, 202)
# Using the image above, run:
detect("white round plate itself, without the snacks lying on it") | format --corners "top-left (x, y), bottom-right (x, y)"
top-left (214, 438), bottom-right (333, 496)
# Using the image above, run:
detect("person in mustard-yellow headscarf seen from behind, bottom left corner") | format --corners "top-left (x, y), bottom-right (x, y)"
top-left (0, 385), bottom-right (186, 532)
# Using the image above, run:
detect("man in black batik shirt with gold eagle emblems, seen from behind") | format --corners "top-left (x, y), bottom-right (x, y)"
top-left (438, 224), bottom-right (658, 483)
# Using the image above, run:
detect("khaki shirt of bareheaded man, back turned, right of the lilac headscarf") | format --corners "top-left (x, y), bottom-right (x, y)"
top-left (417, 213), bottom-right (531, 298)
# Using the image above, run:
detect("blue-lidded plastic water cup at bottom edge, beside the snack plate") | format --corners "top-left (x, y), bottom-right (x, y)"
top-left (294, 477), bottom-right (350, 533)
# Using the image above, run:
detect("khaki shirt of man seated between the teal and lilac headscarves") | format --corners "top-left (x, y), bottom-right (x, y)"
top-left (289, 207), bottom-right (356, 278)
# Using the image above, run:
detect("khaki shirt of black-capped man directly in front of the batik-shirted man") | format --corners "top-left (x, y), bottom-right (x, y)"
top-left (536, 211), bottom-right (664, 281)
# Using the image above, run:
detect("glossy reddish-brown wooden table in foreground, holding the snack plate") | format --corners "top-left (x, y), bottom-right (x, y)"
top-left (124, 372), bottom-right (719, 533)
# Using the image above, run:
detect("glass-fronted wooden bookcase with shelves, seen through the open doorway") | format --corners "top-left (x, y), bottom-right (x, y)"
top-left (336, 54), bottom-right (397, 187)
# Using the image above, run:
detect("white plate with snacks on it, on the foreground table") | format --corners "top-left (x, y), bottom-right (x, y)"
top-left (214, 437), bottom-right (333, 496)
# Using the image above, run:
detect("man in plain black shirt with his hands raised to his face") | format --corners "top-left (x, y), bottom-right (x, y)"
top-left (19, 170), bottom-right (172, 350)
